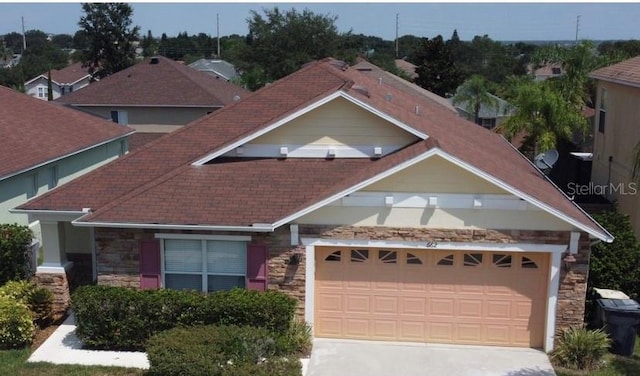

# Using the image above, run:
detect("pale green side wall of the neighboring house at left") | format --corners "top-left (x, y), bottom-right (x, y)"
top-left (0, 140), bottom-right (126, 225)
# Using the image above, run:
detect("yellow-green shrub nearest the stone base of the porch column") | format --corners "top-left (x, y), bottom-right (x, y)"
top-left (0, 281), bottom-right (53, 324)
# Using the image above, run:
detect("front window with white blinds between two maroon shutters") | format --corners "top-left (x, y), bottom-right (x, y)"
top-left (164, 239), bottom-right (247, 292)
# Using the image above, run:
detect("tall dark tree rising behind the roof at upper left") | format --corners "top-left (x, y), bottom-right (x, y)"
top-left (78, 3), bottom-right (140, 78)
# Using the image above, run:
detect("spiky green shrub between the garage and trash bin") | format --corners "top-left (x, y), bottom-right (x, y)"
top-left (551, 328), bottom-right (611, 371)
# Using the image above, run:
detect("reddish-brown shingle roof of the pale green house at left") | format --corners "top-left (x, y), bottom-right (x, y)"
top-left (0, 86), bottom-right (133, 179)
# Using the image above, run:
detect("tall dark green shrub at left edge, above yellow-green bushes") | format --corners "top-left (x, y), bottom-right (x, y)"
top-left (0, 224), bottom-right (33, 285)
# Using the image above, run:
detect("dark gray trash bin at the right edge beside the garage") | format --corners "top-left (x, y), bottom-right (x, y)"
top-left (598, 299), bottom-right (640, 356)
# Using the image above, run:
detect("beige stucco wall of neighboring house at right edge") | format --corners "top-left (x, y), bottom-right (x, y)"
top-left (591, 81), bottom-right (640, 235)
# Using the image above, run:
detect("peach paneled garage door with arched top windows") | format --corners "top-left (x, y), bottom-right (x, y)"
top-left (314, 247), bottom-right (549, 347)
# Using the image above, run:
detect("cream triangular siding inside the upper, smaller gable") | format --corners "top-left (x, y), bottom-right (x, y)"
top-left (249, 98), bottom-right (418, 146)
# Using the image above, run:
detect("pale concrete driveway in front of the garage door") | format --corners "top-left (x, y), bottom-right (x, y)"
top-left (306, 338), bottom-right (555, 376)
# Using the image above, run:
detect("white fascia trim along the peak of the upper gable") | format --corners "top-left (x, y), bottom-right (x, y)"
top-left (192, 90), bottom-right (428, 166)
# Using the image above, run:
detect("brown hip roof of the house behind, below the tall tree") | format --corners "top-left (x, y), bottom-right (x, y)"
top-left (57, 56), bottom-right (250, 107)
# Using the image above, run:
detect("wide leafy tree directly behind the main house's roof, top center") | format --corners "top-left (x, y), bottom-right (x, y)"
top-left (238, 7), bottom-right (339, 89)
